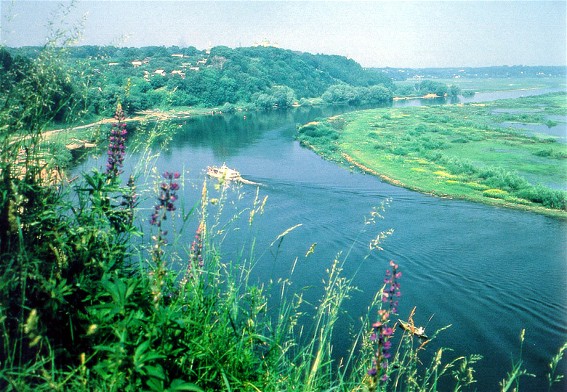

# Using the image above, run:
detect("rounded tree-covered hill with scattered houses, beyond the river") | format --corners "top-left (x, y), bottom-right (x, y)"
top-left (3, 46), bottom-right (394, 115)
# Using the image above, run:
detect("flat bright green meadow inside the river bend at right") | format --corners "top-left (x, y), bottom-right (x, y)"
top-left (298, 94), bottom-right (567, 218)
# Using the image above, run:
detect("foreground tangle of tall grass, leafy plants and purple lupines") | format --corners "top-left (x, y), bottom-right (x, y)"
top-left (0, 44), bottom-right (562, 391)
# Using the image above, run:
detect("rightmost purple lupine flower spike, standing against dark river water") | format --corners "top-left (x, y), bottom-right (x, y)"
top-left (367, 261), bottom-right (402, 385)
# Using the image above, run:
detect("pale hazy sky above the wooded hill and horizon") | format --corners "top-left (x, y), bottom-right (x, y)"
top-left (0, 0), bottom-right (567, 67)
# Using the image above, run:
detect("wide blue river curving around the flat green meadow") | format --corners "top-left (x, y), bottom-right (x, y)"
top-left (79, 87), bottom-right (567, 391)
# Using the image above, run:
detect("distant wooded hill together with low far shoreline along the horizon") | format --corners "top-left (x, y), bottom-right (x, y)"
top-left (10, 46), bottom-right (566, 117)
